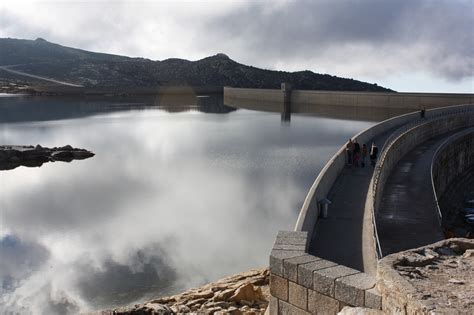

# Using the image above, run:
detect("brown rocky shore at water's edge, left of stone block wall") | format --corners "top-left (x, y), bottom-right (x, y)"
top-left (98, 268), bottom-right (270, 315)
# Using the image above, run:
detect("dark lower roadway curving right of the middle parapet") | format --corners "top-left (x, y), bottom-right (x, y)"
top-left (375, 130), bottom-right (459, 256)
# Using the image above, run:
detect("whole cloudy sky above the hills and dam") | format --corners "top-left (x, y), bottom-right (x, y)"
top-left (0, 0), bottom-right (474, 93)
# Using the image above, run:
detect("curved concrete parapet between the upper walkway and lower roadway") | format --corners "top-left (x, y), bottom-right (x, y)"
top-left (371, 104), bottom-right (474, 259)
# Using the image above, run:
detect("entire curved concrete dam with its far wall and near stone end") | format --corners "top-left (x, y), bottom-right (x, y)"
top-left (224, 85), bottom-right (474, 314)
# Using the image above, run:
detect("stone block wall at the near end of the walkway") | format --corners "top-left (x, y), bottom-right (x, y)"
top-left (270, 231), bottom-right (382, 314)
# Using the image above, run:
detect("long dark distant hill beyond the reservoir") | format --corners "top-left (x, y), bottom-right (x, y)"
top-left (0, 38), bottom-right (391, 92)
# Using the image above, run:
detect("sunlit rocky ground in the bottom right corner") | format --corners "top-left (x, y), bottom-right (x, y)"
top-left (377, 238), bottom-right (474, 315)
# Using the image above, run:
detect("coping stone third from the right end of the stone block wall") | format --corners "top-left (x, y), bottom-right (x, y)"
top-left (313, 265), bottom-right (360, 297)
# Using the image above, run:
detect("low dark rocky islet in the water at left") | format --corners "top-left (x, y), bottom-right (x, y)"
top-left (0, 144), bottom-right (94, 170)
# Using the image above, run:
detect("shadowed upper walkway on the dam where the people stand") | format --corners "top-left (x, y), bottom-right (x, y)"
top-left (309, 130), bottom-right (394, 275)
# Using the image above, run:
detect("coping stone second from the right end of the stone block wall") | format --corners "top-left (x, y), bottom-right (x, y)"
top-left (335, 273), bottom-right (375, 306)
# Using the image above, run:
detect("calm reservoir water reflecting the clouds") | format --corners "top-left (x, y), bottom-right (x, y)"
top-left (0, 98), bottom-right (373, 314)
